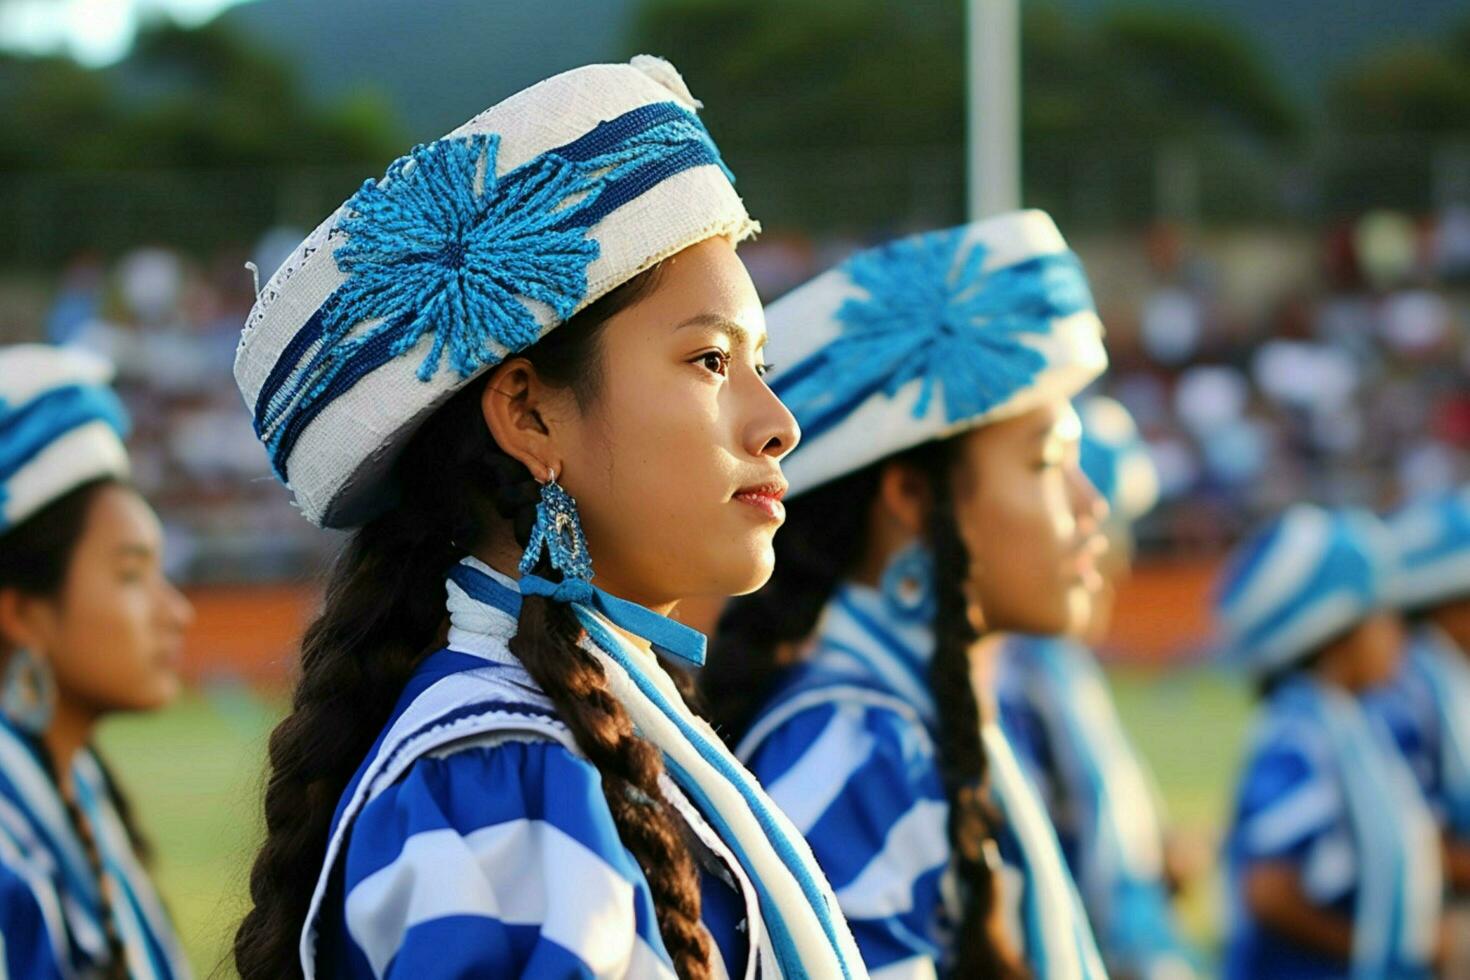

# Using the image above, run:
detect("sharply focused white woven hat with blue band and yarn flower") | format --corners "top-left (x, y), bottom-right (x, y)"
top-left (235, 56), bottom-right (757, 527)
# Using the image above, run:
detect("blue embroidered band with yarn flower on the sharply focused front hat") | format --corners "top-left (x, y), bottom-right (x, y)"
top-left (254, 103), bottom-right (734, 479)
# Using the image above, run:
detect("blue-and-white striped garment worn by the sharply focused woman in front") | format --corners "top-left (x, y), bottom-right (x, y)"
top-left (301, 560), bottom-right (866, 979)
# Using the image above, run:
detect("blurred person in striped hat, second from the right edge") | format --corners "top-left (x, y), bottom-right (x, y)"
top-left (1216, 504), bottom-right (1442, 980)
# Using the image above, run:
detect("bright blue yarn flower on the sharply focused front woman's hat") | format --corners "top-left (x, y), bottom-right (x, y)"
top-left (335, 134), bottom-right (597, 381)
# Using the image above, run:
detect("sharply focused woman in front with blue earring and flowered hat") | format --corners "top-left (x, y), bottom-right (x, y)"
top-left (235, 57), bottom-right (864, 980)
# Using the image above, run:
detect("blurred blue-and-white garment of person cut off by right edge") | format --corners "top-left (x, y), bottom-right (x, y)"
top-left (1366, 624), bottom-right (1470, 839)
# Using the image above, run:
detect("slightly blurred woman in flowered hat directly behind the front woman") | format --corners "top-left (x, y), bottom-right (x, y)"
top-left (701, 212), bottom-right (1107, 977)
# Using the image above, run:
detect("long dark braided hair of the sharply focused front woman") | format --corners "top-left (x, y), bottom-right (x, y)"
top-left (235, 267), bottom-right (710, 980)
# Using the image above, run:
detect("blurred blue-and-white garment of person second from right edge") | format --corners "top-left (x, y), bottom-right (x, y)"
top-left (1226, 676), bottom-right (1442, 980)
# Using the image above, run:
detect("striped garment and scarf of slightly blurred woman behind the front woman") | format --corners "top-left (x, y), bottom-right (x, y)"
top-left (736, 583), bottom-right (1104, 980)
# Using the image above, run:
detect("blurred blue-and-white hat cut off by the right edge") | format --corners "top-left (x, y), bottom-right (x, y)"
top-left (1388, 486), bottom-right (1470, 610)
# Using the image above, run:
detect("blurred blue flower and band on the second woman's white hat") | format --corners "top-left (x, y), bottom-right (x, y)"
top-left (772, 228), bottom-right (1094, 442)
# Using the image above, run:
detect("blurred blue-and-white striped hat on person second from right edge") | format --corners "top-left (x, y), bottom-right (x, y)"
top-left (1214, 504), bottom-right (1392, 676)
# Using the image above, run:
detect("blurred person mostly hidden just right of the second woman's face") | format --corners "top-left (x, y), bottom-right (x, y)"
top-left (995, 395), bottom-right (1197, 980)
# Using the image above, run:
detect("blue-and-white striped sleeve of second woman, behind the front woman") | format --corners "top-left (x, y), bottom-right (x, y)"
top-left (751, 704), bottom-right (950, 980)
